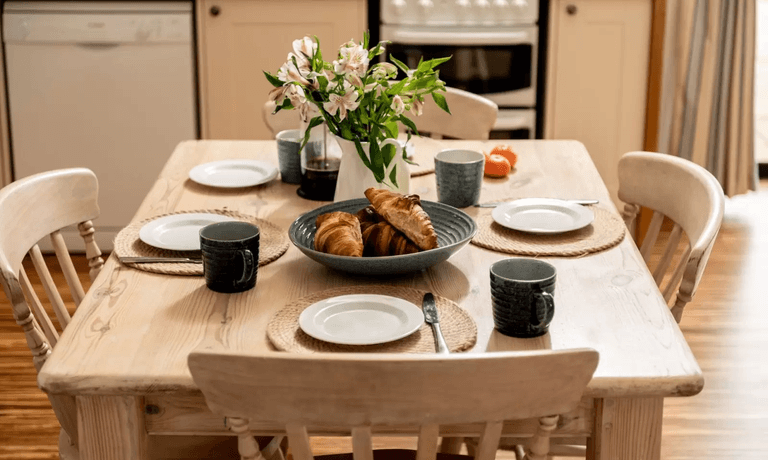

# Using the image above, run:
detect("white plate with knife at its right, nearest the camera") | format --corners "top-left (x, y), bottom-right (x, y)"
top-left (299, 294), bottom-right (424, 345)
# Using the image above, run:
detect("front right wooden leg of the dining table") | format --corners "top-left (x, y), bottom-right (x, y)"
top-left (587, 398), bottom-right (664, 460)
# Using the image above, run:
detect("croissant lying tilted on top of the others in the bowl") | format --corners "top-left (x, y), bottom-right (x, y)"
top-left (365, 188), bottom-right (437, 251)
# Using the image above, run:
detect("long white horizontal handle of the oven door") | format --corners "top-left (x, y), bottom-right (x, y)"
top-left (387, 29), bottom-right (536, 46)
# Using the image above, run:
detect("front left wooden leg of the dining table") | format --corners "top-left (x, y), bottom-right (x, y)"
top-left (77, 396), bottom-right (149, 460)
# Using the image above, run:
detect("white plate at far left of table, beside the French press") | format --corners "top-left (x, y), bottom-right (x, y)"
top-left (189, 160), bottom-right (277, 188)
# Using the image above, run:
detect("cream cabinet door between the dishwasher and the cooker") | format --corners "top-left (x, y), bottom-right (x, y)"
top-left (198, 0), bottom-right (366, 139)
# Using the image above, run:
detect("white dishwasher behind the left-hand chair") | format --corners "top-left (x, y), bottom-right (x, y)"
top-left (3, 1), bottom-right (198, 250)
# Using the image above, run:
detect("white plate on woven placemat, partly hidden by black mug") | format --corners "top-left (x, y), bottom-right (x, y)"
top-left (139, 212), bottom-right (237, 251)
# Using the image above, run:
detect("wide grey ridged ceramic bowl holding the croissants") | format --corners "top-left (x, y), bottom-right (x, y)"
top-left (288, 198), bottom-right (477, 275)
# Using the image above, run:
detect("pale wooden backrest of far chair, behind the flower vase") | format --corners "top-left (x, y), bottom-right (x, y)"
top-left (262, 87), bottom-right (499, 140)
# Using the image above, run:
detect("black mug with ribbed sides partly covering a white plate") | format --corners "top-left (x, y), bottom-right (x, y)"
top-left (200, 221), bottom-right (260, 293)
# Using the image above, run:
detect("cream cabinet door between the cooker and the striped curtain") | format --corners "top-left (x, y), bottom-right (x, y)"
top-left (545, 0), bottom-right (652, 204)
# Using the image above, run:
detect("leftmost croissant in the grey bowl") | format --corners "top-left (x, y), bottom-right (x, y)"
top-left (315, 211), bottom-right (363, 257)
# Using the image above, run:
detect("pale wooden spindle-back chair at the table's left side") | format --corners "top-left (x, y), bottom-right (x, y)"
top-left (0, 168), bottom-right (272, 460)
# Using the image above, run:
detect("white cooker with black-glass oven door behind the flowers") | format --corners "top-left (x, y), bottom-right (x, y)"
top-left (379, 0), bottom-right (543, 139)
